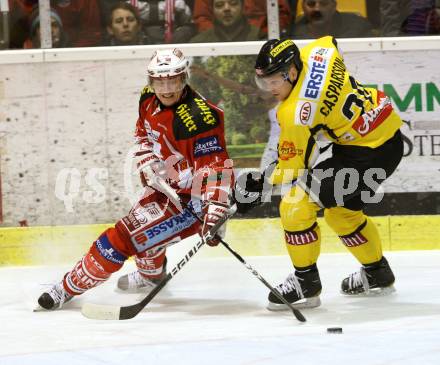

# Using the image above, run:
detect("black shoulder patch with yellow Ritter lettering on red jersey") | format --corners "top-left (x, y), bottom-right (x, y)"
top-left (173, 91), bottom-right (221, 140)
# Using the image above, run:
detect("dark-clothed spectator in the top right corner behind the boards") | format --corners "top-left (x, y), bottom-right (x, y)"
top-left (380, 0), bottom-right (440, 37)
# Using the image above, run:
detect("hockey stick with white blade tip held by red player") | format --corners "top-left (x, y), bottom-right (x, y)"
top-left (81, 209), bottom-right (230, 320)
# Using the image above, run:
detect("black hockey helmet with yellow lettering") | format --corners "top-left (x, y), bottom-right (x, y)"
top-left (255, 39), bottom-right (302, 77)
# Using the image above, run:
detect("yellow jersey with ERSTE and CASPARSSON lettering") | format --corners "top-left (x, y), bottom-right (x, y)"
top-left (272, 36), bottom-right (402, 184)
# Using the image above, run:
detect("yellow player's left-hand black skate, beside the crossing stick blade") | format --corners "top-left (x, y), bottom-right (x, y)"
top-left (267, 269), bottom-right (322, 311)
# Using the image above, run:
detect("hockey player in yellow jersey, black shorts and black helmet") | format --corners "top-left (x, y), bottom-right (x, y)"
top-left (251, 36), bottom-right (403, 310)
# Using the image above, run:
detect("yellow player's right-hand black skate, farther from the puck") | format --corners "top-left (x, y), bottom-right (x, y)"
top-left (341, 257), bottom-right (395, 295)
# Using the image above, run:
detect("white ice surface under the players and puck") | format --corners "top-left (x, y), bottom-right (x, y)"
top-left (0, 240), bottom-right (440, 365)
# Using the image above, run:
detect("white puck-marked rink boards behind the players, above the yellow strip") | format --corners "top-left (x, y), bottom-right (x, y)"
top-left (0, 37), bottom-right (440, 226)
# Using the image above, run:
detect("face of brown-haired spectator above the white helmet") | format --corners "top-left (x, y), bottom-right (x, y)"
top-left (107, 9), bottom-right (139, 44)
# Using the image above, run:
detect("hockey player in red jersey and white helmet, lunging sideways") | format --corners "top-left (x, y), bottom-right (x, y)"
top-left (38, 49), bottom-right (233, 310)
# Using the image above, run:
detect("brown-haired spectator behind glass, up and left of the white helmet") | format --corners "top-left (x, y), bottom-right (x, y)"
top-left (104, 1), bottom-right (150, 46)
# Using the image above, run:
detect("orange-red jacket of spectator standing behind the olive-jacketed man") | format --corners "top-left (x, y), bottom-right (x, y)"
top-left (194, 0), bottom-right (291, 35)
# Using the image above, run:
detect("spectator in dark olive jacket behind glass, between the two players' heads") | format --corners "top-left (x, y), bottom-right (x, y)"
top-left (191, 0), bottom-right (261, 43)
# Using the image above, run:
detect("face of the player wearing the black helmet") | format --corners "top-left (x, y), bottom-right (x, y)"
top-left (255, 66), bottom-right (298, 101)
